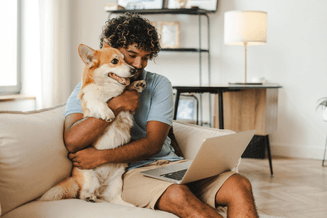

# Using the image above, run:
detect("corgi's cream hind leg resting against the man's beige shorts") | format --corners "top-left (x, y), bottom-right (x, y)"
top-left (101, 166), bottom-right (135, 207)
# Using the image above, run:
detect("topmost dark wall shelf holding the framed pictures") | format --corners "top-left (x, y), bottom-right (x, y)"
top-left (107, 8), bottom-right (215, 16)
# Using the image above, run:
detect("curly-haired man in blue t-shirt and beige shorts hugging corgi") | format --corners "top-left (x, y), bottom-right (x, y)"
top-left (64, 13), bottom-right (257, 217)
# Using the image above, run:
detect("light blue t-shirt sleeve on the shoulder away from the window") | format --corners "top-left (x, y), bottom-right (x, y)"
top-left (148, 76), bottom-right (174, 126)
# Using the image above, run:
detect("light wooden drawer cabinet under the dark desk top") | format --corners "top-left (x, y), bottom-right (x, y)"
top-left (214, 88), bottom-right (278, 136)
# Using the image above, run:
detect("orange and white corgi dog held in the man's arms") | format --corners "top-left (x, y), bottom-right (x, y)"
top-left (40, 42), bottom-right (146, 206)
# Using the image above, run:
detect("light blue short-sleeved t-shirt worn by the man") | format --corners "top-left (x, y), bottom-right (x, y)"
top-left (65, 70), bottom-right (182, 169)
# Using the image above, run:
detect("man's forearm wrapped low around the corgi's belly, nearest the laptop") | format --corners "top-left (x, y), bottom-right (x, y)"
top-left (69, 121), bottom-right (170, 169)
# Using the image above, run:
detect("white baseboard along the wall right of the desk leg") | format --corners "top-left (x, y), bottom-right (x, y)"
top-left (270, 143), bottom-right (327, 160)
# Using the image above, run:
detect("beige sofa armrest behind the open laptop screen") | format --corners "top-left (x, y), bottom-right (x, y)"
top-left (173, 120), bottom-right (240, 172)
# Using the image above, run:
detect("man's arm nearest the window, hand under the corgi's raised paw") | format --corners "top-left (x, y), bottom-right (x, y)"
top-left (64, 91), bottom-right (140, 152)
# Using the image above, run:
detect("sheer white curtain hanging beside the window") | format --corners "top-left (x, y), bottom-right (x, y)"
top-left (22, 0), bottom-right (71, 109)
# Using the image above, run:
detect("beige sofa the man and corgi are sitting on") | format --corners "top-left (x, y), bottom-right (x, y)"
top-left (0, 105), bottom-right (238, 218)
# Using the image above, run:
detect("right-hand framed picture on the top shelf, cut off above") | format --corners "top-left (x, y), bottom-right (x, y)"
top-left (165, 0), bottom-right (218, 11)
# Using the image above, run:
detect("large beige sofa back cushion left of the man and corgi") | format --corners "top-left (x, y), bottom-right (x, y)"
top-left (0, 105), bottom-right (72, 215)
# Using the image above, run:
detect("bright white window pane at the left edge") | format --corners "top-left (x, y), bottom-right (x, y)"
top-left (0, 0), bottom-right (21, 95)
